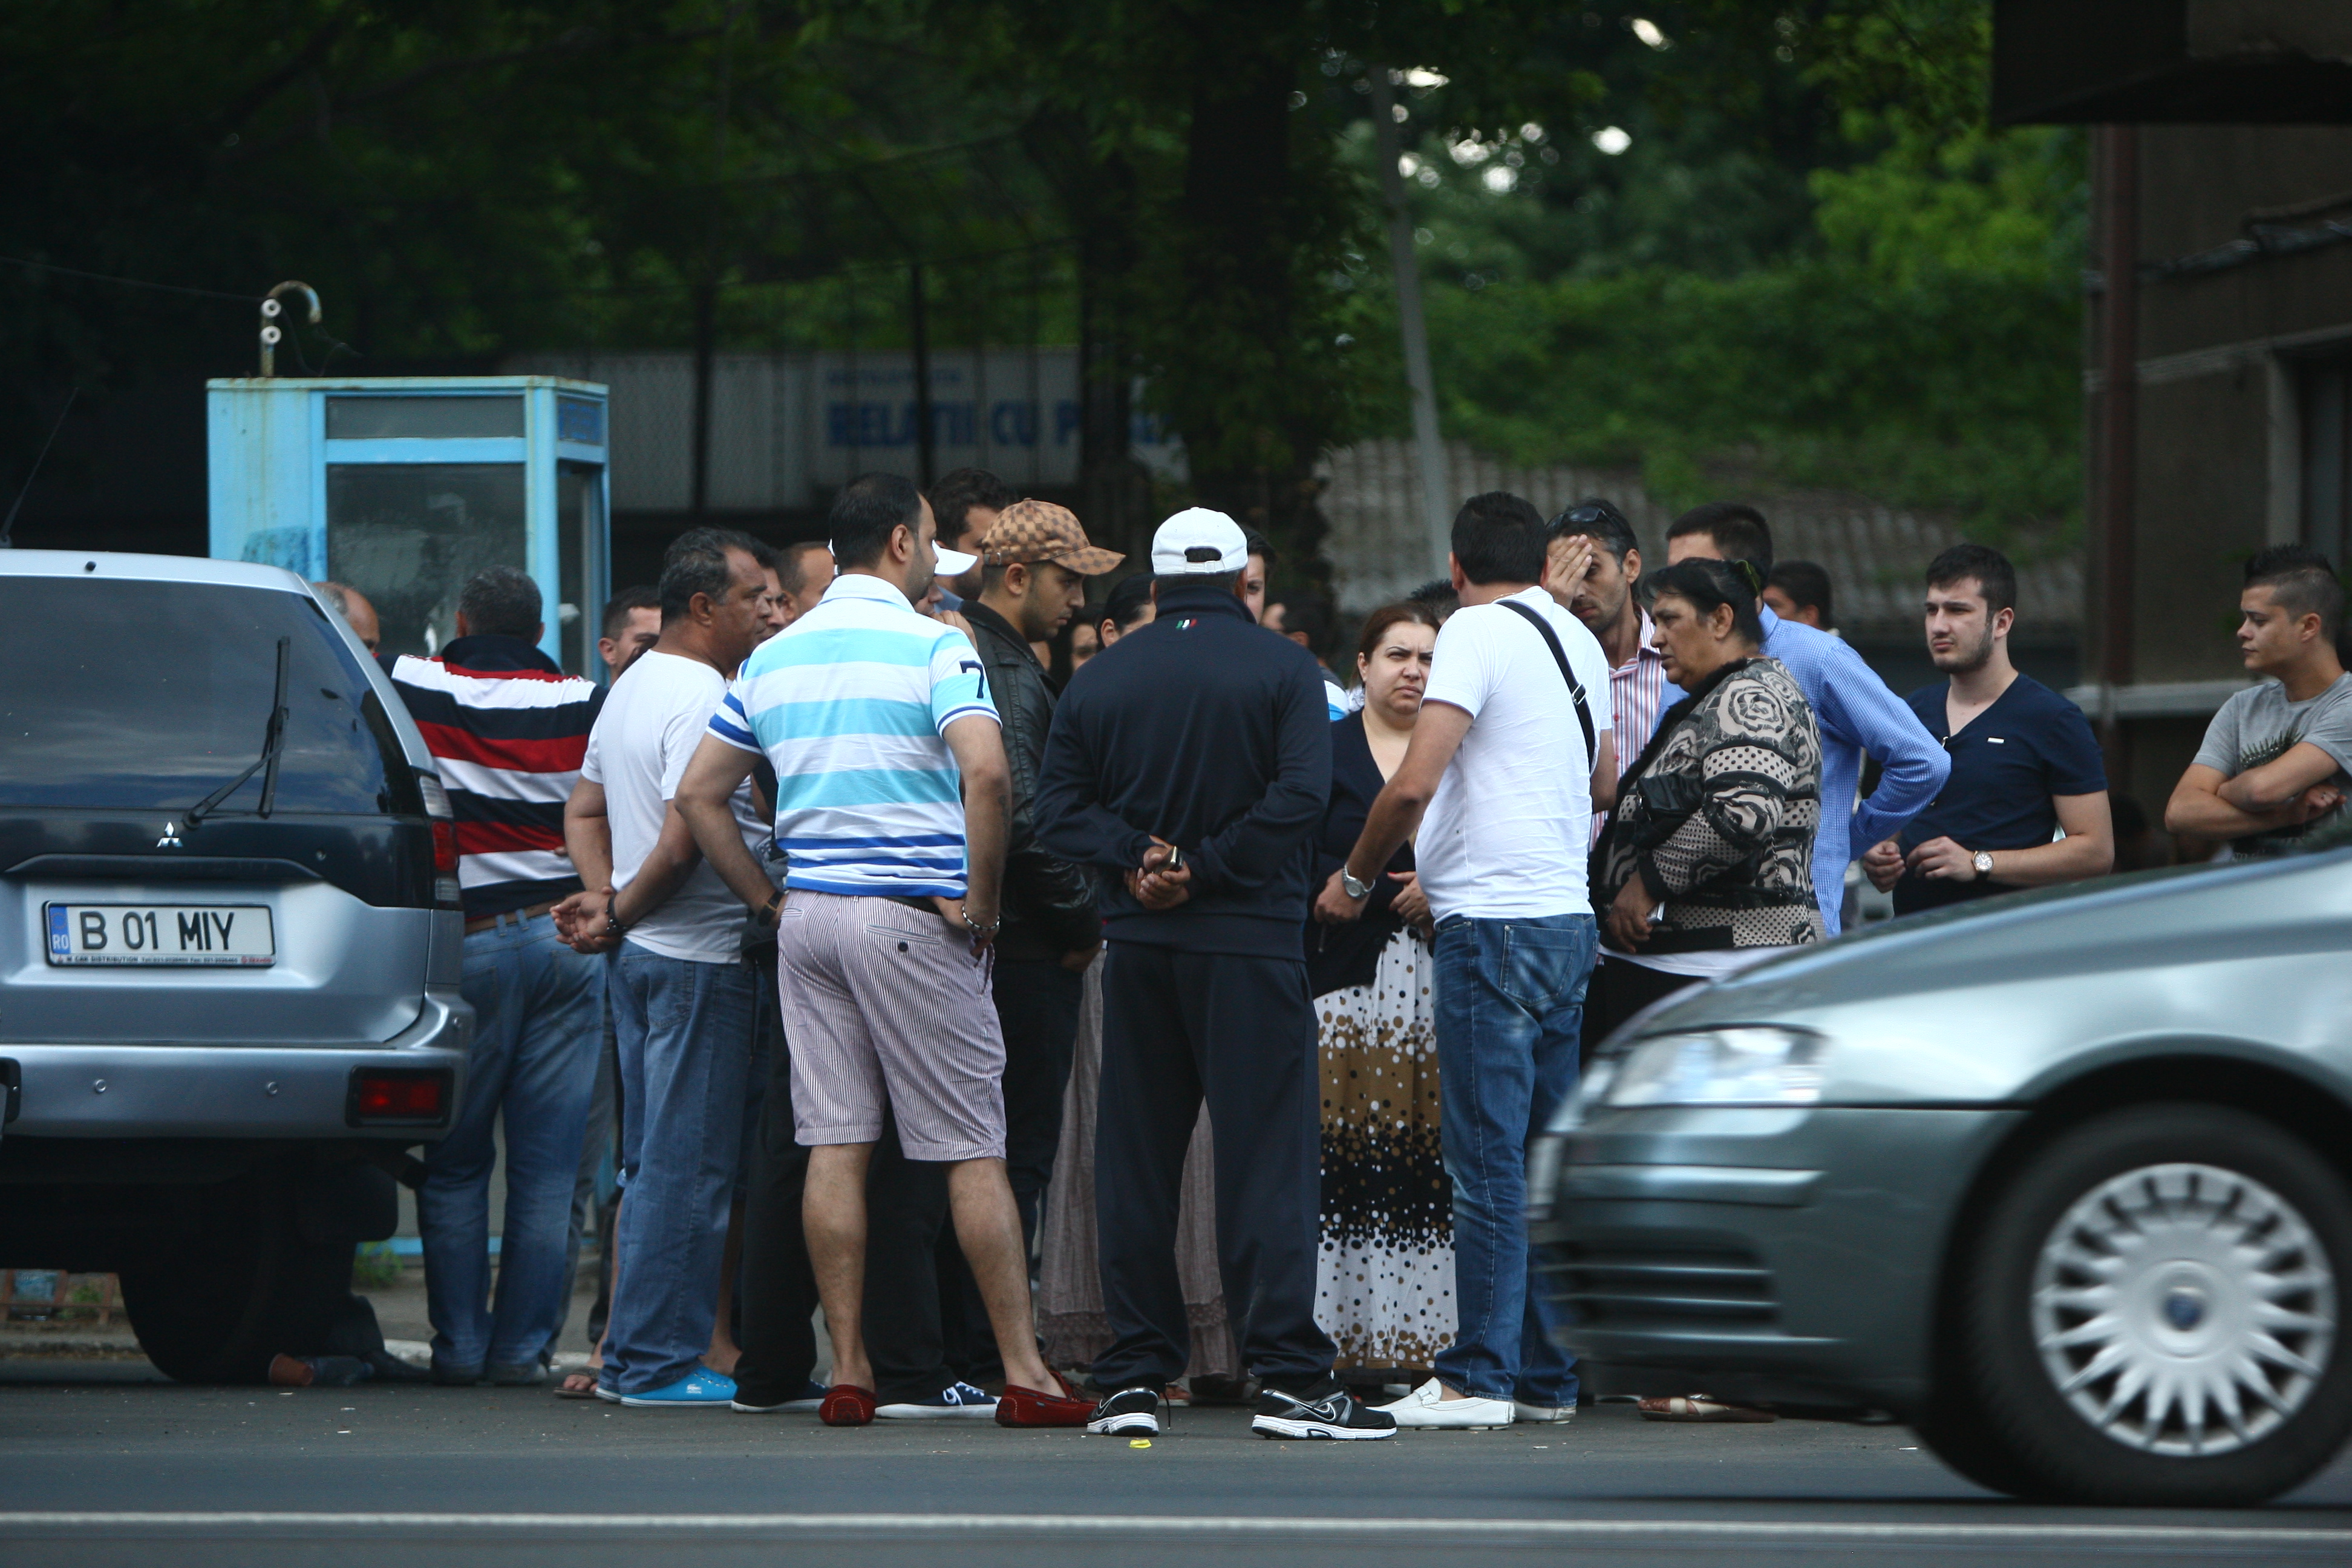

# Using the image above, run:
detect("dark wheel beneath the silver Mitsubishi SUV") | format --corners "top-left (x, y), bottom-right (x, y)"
top-left (122, 1171), bottom-right (350, 1382)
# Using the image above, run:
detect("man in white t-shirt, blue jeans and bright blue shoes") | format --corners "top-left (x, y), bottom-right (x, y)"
top-left (564, 529), bottom-right (769, 1411)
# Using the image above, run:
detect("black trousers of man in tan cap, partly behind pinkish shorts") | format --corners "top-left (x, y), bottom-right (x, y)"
top-left (866, 959), bottom-right (1086, 1403)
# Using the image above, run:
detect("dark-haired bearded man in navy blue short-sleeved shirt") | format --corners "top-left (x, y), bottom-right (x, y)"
top-left (1863, 546), bottom-right (2114, 915)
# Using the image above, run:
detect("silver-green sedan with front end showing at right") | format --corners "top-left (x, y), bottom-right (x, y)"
top-left (1529, 849), bottom-right (2352, 1504)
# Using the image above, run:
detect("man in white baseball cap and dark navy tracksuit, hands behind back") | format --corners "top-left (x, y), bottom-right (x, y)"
top-left (1035, 508), bottom-right (1395, 1439)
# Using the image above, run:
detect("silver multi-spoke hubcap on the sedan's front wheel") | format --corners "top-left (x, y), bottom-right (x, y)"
top-left (2032, 1164), bottom-right (2336, 1455)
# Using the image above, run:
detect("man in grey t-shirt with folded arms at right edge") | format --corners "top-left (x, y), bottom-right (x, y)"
top-left (2164, 546), bottom-right (2352, 856)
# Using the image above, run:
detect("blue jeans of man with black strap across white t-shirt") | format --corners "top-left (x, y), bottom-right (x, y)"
top-left (1435, 915), bottom-right (1597, 1406)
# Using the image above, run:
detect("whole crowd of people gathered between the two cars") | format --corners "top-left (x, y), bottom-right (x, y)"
top-left (334, 470), bottom-right (2352, 1439)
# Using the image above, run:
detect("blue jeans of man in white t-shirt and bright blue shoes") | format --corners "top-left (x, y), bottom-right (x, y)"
top-left (597, 942), bottom-right (753, 1394)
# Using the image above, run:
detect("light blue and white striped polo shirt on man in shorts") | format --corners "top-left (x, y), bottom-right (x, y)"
top-left (710, 573), bottom-right (998, 898)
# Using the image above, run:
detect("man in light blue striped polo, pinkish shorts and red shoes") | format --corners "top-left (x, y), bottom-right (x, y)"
top-left (675, 475), bottom-right (1091, 1427)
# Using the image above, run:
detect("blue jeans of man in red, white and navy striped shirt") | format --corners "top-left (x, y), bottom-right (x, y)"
top-left (416, 915), bottom-right (604, 1375)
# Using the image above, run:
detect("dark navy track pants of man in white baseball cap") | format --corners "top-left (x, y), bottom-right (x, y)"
top-left (1094, 940), bottom-right (1333, 1392)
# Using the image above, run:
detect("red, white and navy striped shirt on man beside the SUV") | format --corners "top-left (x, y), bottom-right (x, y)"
top-left (390, 637), bottom-right (604, 919)
